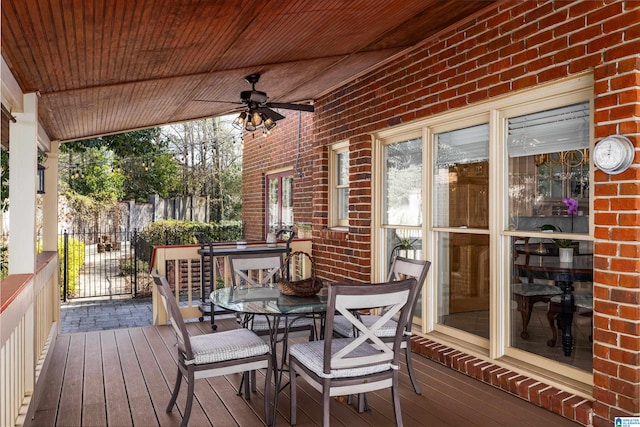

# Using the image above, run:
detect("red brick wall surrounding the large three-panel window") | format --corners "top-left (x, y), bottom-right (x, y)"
top-left (242, 0), bottom-right (640, 426)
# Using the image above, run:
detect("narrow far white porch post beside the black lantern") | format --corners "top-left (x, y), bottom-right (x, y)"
top-left (42, 141), bottom-right (60, 252)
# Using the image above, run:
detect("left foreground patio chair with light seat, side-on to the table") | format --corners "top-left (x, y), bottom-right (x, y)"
top-left (153, 274), bottom-right (272, 427)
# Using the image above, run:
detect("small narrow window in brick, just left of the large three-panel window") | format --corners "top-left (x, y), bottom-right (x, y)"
top-left (329, 142), bottom-right (349, 227)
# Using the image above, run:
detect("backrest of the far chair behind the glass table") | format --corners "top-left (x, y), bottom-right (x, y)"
top-left (229, 254), bottom-right (282, 287)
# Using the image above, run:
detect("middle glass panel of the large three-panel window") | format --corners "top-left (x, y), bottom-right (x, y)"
top-left (433, 123), bottom-right (489, 339)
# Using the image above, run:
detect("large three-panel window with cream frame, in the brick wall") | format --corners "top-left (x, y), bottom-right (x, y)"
top-left (372, 76), bottom-right (593, 384)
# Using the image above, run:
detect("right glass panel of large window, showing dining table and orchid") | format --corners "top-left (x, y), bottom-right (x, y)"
top-left (505, 102), bottom-right (593, 371)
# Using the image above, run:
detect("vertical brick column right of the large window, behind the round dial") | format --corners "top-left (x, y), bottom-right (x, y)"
top-left (593, 53), bottom-right (640, 426)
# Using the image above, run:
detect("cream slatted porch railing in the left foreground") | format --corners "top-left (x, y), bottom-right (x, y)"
top-left (0, 252), bottom-right (60, 426)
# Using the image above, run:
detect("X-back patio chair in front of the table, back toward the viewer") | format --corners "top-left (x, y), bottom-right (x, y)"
top-left (289, 279), bottom-right (417, 426)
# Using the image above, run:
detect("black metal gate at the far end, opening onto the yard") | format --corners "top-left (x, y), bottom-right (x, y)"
top-left (60, 230), bottom-right (139, 301)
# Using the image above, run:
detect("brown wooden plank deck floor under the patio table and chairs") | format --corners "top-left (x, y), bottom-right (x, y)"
top-left (26, 319), bottom-right (577, 427)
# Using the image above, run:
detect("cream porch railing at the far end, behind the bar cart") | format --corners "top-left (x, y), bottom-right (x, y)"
top-left (151, 240), bottom-right (311, 325)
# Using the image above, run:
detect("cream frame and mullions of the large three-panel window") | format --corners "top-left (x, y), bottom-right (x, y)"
top-left (371, 73), bottom-right (594, 392)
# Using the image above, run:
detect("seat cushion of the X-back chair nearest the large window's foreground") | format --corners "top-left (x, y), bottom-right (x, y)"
top-left (289, 338), bottom-right (392, 378)
